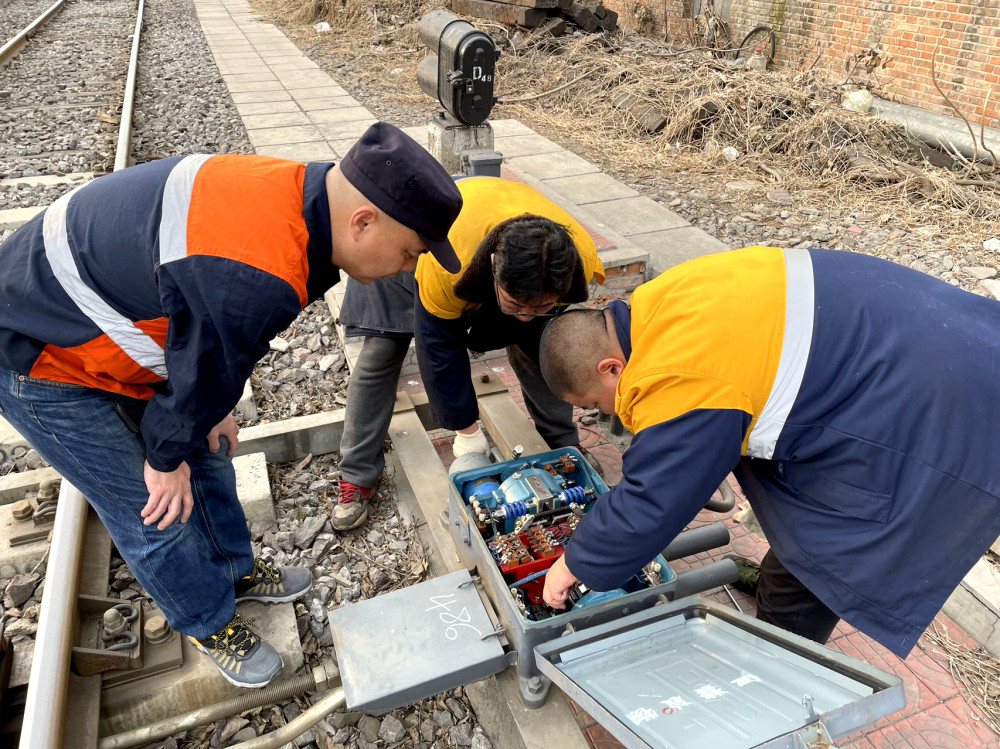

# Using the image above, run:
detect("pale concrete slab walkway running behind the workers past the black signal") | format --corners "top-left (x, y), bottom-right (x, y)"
top-left (195, 0), bottom-right (726, 273)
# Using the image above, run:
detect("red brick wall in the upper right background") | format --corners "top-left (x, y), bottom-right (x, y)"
top-left (606, 0), bottom-right (1000, 127)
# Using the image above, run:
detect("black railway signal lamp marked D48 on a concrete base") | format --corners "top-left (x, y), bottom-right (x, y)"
top-left (417, 10), bottom-right (500, 125)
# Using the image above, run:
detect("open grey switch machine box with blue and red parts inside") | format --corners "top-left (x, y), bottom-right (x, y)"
top-left (444, 447), bottom-right (737, 707)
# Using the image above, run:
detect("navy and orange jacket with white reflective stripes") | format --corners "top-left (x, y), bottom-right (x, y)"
top-left (0, 155), bottom-right (337, 470)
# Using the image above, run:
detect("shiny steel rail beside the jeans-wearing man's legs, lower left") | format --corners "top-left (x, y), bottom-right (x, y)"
top-left (18, 479), bottom-right (88, 749)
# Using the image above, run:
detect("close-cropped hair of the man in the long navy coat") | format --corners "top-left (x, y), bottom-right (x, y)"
top-left (538, 309), bottom-right (613, 400)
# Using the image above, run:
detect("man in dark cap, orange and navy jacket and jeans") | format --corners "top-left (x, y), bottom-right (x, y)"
top-left (0, 123), bottom-right (461, 687)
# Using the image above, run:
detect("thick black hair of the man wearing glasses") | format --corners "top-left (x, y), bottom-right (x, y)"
top-left (480, 213), bottom-right (580, 304)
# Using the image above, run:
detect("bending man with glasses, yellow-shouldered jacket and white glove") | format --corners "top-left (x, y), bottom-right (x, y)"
top-left (332, 177), bottom-right (604, 530)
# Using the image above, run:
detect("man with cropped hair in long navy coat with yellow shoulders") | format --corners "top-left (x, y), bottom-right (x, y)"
top-left (541, 247), bottom-right (1000, 657)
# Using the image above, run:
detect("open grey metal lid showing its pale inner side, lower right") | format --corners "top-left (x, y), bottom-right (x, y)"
top-left (535, 597), bottom-right (905, 749)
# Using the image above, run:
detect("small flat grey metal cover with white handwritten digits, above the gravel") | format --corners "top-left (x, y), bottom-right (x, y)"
top-left (329, 570), bottom-right (507, 714)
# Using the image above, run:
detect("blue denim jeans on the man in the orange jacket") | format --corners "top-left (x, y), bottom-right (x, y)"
top-left (0, 368), bottom-right (253, 639)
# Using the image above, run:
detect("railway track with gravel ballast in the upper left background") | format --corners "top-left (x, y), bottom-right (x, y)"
top-left (0, 0), bottom-right (142, 210)
